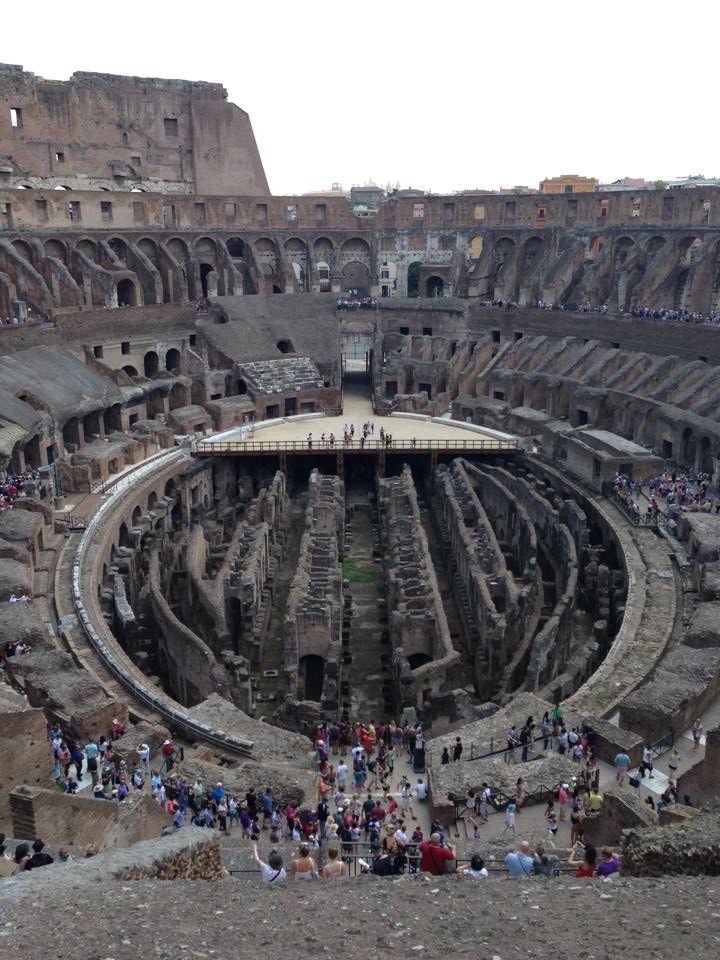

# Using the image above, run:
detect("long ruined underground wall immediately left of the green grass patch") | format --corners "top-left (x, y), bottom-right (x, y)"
top-left (283, 469), bottom-right (345, 716)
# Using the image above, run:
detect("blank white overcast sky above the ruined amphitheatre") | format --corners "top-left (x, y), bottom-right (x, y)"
top-left (0, 0), bottom-right (720, 194)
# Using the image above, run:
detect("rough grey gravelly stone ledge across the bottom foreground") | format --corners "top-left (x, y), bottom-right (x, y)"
top-left (0, 866), bottom-right (720, 960)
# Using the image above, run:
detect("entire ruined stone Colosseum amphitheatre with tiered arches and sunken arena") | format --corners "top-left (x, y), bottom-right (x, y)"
top-left (0, 64), bottom-right (720, 957)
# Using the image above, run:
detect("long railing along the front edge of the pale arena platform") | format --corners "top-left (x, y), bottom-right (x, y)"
top-left (191, 437), bottom-right (519, 456)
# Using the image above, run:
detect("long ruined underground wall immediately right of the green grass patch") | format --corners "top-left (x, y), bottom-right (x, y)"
top-left (378, 465), bottom-right (460, 707)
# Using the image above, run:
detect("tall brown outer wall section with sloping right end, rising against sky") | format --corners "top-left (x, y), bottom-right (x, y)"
top-left (0, 64), bottom-right (269, 196)
